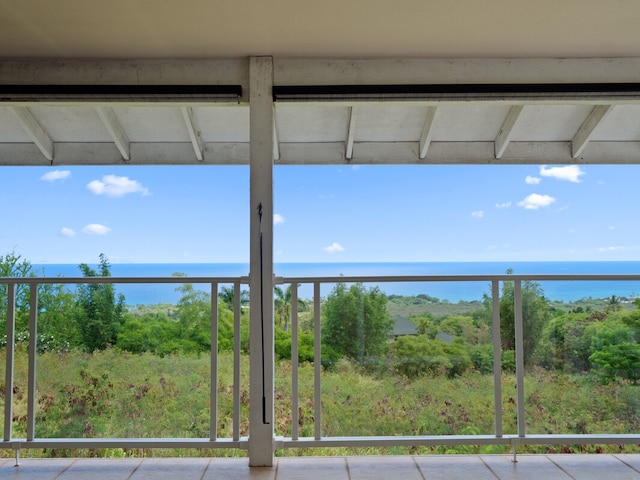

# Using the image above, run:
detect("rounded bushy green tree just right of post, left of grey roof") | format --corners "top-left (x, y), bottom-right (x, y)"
top-left (322, 283), bottom-right (393, 359)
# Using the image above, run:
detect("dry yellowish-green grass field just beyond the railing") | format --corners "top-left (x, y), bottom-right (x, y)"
top-left (0, 347), bottom-right (640, 456)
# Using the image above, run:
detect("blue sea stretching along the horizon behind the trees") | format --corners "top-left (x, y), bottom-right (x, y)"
top-left (32, 262), bottom-right (640, 305)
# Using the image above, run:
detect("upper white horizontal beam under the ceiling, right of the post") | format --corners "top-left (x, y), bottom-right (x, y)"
top-left (274, 57), bottom-right (640, 85)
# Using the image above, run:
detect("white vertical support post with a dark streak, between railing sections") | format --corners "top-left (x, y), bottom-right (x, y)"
top-left (249, 57), bottom-right (274, 467)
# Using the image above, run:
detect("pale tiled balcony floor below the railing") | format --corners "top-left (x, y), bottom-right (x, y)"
top-left (0, 454), bottom-right (640, 480)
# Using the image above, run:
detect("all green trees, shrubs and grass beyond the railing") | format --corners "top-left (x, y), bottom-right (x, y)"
top-left (0, 253), bottom-right (640, 455)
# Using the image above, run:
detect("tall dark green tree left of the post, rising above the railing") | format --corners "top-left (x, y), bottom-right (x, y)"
top-left (76, 253), bottom-right (125, 352)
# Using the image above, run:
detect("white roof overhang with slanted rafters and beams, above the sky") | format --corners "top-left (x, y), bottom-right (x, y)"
top-left (0, 59), bottom-right (640, 165)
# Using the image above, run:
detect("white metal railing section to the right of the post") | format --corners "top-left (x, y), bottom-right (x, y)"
top-left (276, 274), bottom-right (640, 459)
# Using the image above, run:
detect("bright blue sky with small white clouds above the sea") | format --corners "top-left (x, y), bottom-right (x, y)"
top-left (0, 165), bottom-right (640, 264)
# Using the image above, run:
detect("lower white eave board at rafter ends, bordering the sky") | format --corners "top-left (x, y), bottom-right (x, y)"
top-left (0, 141), bottom-right (640, 166)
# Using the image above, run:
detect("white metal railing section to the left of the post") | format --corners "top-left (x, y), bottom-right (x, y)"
top-left (0, 276), bottom-right (248, 459)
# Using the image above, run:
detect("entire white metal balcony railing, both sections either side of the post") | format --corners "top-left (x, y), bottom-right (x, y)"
top-left (0, 274), bottom-right (640, 464)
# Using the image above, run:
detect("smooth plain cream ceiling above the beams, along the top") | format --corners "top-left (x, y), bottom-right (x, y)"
top-left (0, 0), bottom-right (640, 58)
